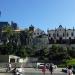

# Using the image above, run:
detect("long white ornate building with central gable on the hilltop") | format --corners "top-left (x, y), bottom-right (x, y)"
top-left (47, 25), bottom-right (75, 44)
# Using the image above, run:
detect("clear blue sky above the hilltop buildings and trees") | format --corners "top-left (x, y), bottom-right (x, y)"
top-left (0, 0), bottom-right (75, 32)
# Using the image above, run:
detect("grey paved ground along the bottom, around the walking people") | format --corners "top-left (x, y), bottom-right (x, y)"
top-left (0, 68), bottom-right (75, 75)
